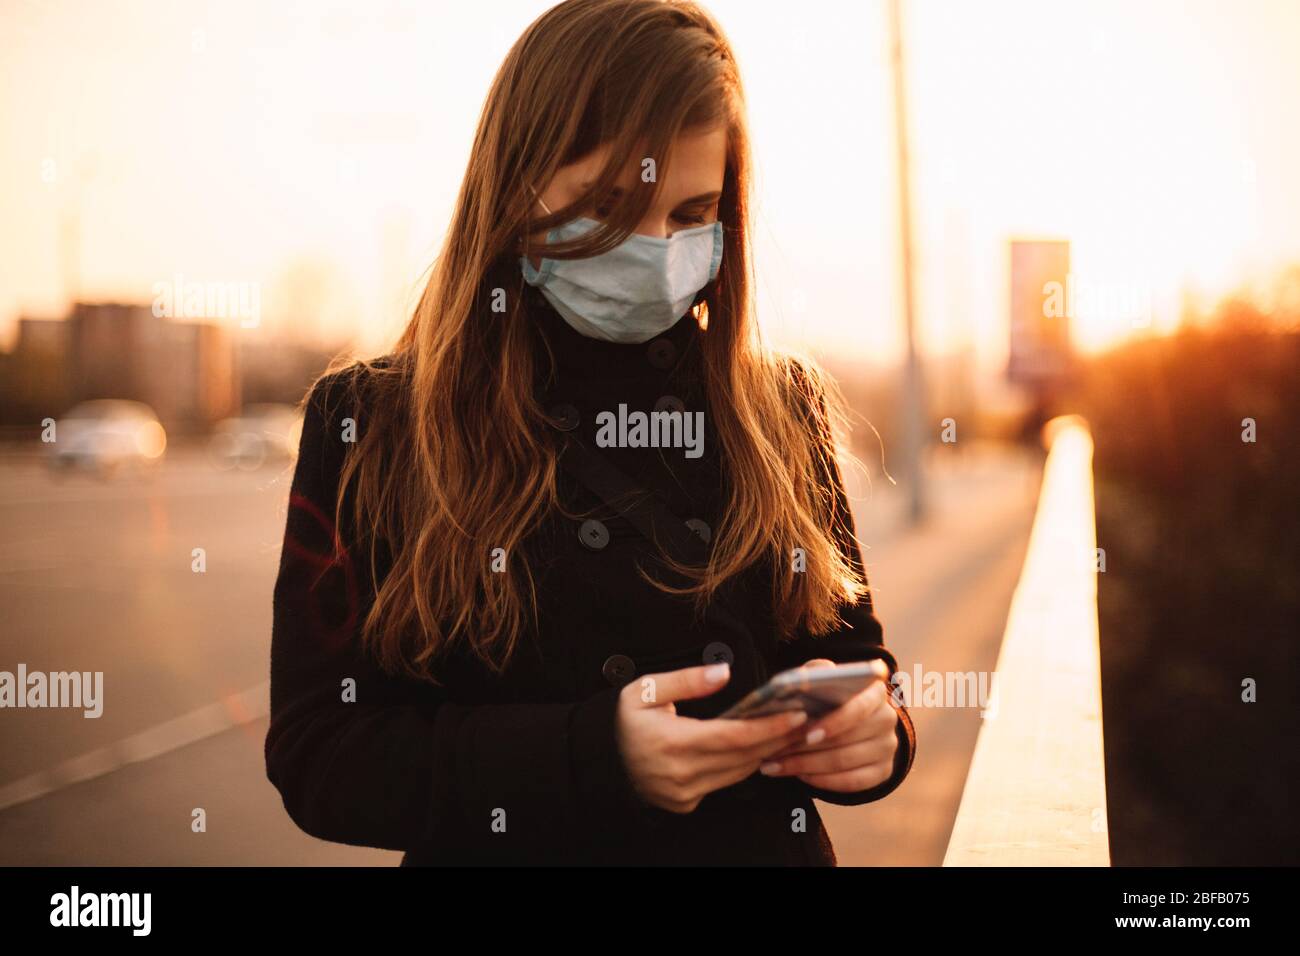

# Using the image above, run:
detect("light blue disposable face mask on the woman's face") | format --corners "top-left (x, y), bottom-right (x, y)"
top-left (520, 193), bottom-right (723, 342)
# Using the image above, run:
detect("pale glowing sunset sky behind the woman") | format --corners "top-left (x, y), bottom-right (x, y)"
top-left (0, 0), bottom-right (1300, 367)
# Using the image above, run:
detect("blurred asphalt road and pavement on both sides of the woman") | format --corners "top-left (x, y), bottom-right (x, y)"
top-left (0, 449), bottom-right (1037, 865)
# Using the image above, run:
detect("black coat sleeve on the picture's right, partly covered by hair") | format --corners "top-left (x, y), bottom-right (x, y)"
top-left (777, 364), bottom-right (917, 806)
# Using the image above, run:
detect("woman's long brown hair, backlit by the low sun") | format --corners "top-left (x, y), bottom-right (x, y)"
top-left (335, 0), bottom-right (866, 680)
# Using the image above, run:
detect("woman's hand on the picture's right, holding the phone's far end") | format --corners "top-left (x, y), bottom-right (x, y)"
top-left (759, 658), bottom-right (898, 793)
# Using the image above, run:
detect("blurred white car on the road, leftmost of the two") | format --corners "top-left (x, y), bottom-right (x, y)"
top-left (47, 398), bottom-right (166, 476)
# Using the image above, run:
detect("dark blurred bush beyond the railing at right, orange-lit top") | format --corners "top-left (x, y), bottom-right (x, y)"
top-left (1078, 300), bottom-right (1300, 865)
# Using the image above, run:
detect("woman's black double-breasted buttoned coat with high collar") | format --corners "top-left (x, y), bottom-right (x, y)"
top-left (267, 290), bottom-right (915, 865)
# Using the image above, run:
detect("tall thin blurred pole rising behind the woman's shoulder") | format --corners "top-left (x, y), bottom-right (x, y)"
top-left (889, 0), bottom-right (926, 524)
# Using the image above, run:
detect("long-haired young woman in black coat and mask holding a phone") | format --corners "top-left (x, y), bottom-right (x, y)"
top-left (267, 0), bottom-right (915, 865)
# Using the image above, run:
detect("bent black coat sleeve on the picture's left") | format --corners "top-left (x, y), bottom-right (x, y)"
top-left (265, 367), bottom-right (641, 849)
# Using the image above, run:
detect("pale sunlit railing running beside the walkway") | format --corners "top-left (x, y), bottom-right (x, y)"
top-left (944, 416), bottom-right (1110, 866)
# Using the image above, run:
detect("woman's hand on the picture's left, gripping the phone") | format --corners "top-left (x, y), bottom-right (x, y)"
top-left (618, 663), bottom-right (807, 813)
